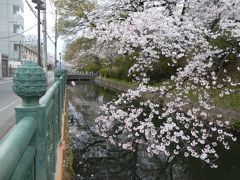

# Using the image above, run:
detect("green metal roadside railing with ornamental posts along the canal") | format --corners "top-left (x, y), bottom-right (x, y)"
top-left (0, 62), bottom-right (67, 180)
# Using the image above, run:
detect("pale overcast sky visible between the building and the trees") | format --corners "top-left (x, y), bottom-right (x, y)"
top-left (23, 0), bottom-right (63, 55)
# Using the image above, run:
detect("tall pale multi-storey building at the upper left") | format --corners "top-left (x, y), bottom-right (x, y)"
top-left (0, 0), bottom-right (24, 71)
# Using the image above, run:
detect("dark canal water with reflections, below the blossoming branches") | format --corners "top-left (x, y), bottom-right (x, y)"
top-left (68, 84), bottom-right (240, 180)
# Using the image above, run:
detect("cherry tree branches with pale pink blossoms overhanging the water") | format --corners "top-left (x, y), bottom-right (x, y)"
top-left (87, 0), bottom-right (240, 167)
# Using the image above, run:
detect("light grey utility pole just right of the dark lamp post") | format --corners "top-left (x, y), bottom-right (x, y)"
top-left (42, 0), bottom-right (47, 78)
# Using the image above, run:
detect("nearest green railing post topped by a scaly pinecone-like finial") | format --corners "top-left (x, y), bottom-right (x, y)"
top-left (13, 61), bottom-right (49, 180)
